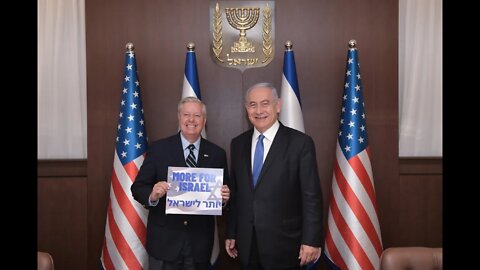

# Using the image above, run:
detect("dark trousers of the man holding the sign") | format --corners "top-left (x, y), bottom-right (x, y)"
top-left (148, 237), bottom-right (210, 270)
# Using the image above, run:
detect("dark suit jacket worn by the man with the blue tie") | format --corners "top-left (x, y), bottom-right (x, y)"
top-left (227, 123), bottom-right (322, 269)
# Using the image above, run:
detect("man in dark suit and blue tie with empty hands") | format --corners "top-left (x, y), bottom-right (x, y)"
top-left (225, 83), bottom-right (322, 270)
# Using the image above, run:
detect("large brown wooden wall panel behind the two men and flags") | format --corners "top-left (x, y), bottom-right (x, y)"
top-left (85, 0), bottom-right (399, 269)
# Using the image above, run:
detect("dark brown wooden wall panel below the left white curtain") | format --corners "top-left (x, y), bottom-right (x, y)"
top-left (37, 160), bottom-right (87, 270)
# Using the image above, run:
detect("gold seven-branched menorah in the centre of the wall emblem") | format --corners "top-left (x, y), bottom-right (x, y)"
top-left (225, 8), bottom-right (260, 53)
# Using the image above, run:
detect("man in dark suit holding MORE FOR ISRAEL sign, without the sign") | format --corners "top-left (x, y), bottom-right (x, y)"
top-left (131, 97), bottom-right (230, 270)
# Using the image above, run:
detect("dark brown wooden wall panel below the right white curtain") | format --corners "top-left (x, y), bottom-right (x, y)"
top-left (395, 158), bottom-right (443, 247)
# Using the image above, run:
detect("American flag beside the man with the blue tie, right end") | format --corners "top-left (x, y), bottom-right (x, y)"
top-left (325, 40), bottom-right (383, 269)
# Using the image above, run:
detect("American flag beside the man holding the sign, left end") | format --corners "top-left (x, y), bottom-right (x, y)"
top-left (101, 43), bottom-right (148, 270)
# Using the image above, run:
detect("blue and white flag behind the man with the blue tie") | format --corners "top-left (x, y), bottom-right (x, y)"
top-left (279, 41), bottom-right (305, 132)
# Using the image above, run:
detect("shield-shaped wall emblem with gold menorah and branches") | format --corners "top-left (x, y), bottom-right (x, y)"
top-left (210, 1), bottom-right (275, 72)
